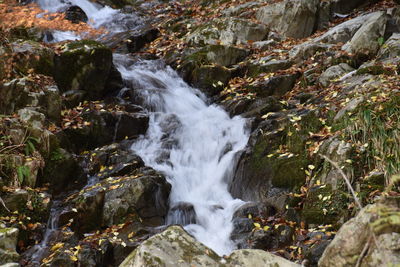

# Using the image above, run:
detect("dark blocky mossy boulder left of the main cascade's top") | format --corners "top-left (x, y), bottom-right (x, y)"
top-left (54, 40), bottom-right (122, 99)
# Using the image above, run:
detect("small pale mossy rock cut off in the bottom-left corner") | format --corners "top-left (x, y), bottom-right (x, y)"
top-left (0, 228), bottom-right (19, 264)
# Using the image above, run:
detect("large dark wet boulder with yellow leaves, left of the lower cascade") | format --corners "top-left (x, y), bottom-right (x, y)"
top-left (65, 168), bottom-right (171, 233)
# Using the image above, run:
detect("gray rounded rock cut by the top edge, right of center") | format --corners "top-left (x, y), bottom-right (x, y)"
top-left (256, 0), bottom-right (319, 38)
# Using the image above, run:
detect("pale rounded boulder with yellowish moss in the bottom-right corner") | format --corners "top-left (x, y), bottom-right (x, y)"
top-left (318, 203), bottom-right (400, 267)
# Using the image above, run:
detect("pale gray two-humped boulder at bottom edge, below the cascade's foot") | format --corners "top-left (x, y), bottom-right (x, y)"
top-left (120, 226), bottom-right (299, 267)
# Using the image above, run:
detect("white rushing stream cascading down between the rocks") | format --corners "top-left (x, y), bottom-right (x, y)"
top-left (38, 0), bottom-right (249, 255)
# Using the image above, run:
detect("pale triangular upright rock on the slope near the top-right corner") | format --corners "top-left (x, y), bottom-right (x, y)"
top-left (342, 12), bottom-right (387, 56)
